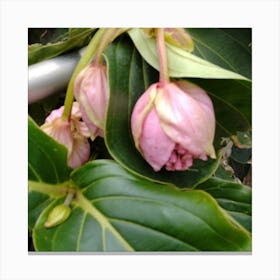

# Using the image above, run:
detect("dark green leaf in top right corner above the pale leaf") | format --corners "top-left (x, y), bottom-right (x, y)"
top-left (187, 28), bottom-right (252, 79)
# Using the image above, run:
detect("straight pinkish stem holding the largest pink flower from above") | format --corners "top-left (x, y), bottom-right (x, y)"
top-left (157, 28), bottom-right (169, 85)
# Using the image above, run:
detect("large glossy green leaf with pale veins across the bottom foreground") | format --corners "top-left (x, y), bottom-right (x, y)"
top-left (34, 160), bottom-right (251, 252)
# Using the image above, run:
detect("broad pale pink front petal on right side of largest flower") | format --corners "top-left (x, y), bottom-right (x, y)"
top-left (155, 83), bottom-right (214, 156)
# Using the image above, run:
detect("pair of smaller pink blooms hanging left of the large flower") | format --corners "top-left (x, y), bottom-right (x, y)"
top-left (41, 64), bottom-right (109, 168)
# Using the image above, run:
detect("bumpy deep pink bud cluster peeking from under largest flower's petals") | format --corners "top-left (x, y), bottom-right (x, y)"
top-left (165, 144), bottom-right (193, 171)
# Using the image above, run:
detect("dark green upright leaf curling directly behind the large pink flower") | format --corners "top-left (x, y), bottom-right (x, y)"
top-left (105, 37), bottom-right (218, 187)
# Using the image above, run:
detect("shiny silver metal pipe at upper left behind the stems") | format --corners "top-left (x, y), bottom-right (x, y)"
top-left (28, 48), bottom-right (85, 104)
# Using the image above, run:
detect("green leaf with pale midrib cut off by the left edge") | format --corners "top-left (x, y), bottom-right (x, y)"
top-left (28, 117), bottom-right (72, 228)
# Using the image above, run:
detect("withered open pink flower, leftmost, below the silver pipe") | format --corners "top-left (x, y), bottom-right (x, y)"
top-left (41, 102), bottom-right (90, 168)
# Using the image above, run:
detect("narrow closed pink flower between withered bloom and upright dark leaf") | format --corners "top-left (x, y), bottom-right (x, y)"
top-left (74, 64), bottom-right (109, 140)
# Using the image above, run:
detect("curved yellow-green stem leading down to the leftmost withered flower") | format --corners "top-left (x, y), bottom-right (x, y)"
top-left (62, 28), bottom-right (106, 120)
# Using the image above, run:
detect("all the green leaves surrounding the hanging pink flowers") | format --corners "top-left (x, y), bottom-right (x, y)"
top-left (28, 28), bottom-right (252, 252)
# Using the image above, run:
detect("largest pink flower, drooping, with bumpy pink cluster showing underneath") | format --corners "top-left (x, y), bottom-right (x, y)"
top-left (131, 81), bottom-right (216, 171)
